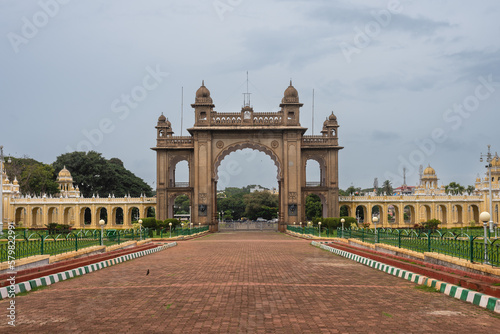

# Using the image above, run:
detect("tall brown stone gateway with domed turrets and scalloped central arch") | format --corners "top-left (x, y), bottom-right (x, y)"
top-left (153, 82), bottom-right (342, 232)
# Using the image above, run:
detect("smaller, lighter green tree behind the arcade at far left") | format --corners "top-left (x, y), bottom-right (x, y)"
top-left (5, 157), bottom-right (59, 195)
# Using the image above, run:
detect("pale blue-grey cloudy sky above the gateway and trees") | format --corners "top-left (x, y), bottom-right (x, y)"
top-left (0, 0), bottom-right (500, 192)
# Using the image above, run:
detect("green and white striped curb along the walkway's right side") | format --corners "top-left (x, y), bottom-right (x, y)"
top-left (311, 241), bottom-right (500, 313)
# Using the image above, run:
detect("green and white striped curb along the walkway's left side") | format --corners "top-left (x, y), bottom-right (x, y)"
top-left (0, 242), bottom-right (177, 300)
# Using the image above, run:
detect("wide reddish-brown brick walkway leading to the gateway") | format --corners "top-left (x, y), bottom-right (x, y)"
top-left (0, 232), bottom-right (500, 334)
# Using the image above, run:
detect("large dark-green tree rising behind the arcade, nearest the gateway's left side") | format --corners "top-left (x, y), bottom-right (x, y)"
top-left (52, 151), bottom-right (152, 197)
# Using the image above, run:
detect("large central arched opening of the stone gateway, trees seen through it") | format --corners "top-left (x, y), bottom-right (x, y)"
top-left (215, 143), bottom-right (280, 229)
